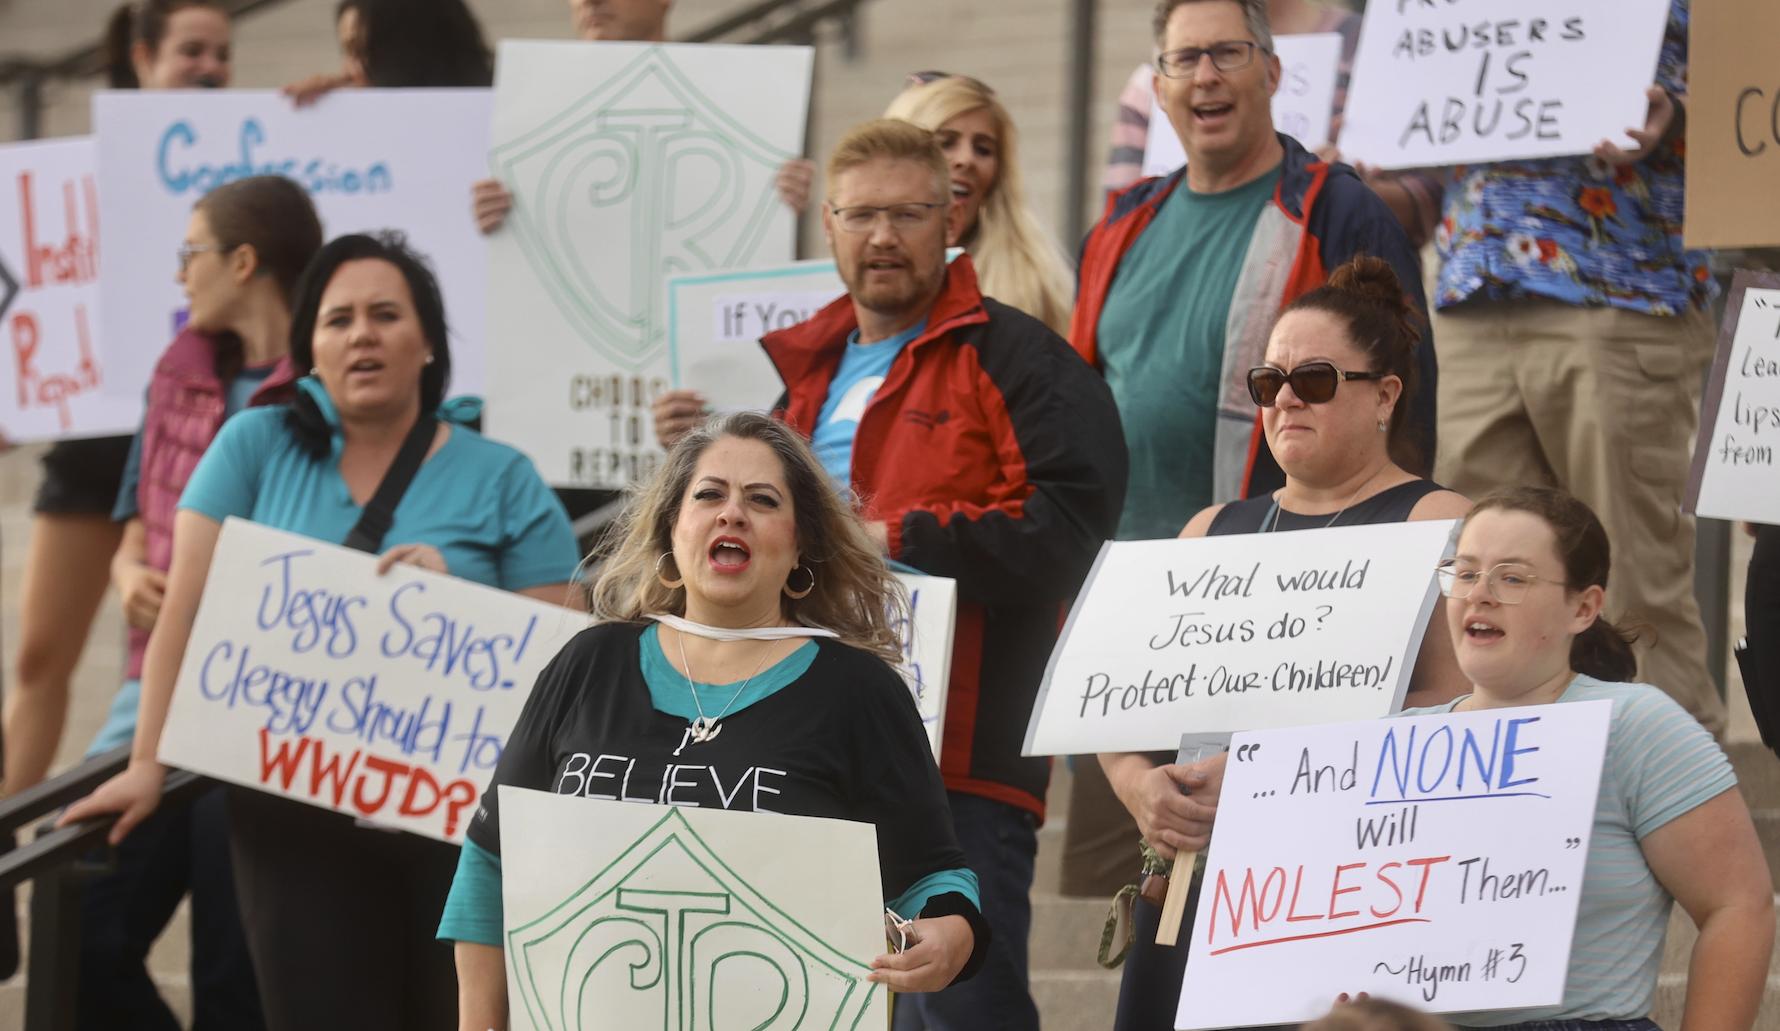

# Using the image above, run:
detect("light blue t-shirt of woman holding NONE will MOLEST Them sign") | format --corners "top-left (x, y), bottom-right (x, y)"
top-left (1403, 673), bottom-right (1737, 1027)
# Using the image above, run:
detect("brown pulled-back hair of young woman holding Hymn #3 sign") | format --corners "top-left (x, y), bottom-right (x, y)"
top-left (1465, 486), bottom-right (1638, 682)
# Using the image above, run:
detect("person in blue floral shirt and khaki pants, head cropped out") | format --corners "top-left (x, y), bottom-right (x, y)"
top-left (1435, 0), bottom-right (1725, 734)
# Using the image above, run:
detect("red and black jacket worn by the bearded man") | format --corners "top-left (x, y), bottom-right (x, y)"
top-left (760, 256), bottom-right (1125, 819)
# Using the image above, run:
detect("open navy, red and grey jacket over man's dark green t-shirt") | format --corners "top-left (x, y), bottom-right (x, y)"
top-left (1070, 134), bottom-right (1438, 498)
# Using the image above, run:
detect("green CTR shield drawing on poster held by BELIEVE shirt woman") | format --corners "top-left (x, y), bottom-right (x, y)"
top-left (502, 789), bottom-right (883, 1031)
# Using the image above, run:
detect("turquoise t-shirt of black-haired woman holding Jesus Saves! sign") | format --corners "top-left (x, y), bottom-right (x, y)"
top-left (180, 377), bottom-right (577, 591)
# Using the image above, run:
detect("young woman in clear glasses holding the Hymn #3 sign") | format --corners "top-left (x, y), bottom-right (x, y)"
top-left (1404, 486), bottom-right (1775, 1031)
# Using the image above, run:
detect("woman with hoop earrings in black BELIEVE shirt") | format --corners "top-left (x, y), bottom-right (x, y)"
top-left (440, 413), bottom-right (988, 1031)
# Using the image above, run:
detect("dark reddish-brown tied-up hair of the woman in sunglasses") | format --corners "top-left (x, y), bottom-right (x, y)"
top-left (1280, 255), bottom-right (1426, 470)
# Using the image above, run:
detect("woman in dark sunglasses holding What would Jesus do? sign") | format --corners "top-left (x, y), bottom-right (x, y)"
top-left (1100, 255), bottom-right (1470, 1031)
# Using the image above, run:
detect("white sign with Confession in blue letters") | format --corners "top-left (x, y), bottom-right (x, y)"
top-left (93, 89), bottom-right (490, 399)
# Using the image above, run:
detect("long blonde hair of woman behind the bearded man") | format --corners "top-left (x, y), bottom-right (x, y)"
top-left (885, 75), bottom-right (1073, 333)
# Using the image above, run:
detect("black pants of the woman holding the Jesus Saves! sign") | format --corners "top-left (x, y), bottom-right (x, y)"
top-left (230, 789), bottom-right (457, 1031)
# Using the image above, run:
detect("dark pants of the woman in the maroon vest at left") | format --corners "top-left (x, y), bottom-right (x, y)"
top-left (75, 787), bottom-right (265, 1031)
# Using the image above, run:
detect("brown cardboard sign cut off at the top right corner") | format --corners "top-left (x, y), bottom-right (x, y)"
top-left (1682, 0), bottom-right (1780, 248)
